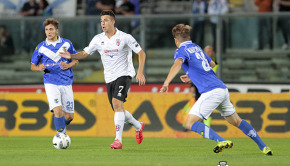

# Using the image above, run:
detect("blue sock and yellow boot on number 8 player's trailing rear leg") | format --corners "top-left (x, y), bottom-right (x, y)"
top-left (238, 120), bottom-right (273, 156)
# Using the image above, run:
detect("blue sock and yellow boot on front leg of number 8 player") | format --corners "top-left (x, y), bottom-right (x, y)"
top-left (191, 122), bottom-right (233, 153)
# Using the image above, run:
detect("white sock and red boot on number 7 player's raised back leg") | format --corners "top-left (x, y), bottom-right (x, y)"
top-left (125, 110), bottom-right (145, 144)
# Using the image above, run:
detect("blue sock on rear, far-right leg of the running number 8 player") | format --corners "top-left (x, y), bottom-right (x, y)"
top-left (238, 120), bottom-right (266, 150)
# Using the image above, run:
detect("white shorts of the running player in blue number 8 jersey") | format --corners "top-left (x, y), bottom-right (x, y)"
top-left (188, 88), bottom-right (236, 119)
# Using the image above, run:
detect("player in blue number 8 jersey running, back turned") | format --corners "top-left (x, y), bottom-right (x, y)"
top-left (160, 24), bottom-right (273, 155)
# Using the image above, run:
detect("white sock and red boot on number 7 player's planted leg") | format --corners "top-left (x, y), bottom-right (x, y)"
top-left (110, 112), bottom-right (125, 149)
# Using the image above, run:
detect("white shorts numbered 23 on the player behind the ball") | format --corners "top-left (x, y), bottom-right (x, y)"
top-left (44, 84), bottom-right (74, 113)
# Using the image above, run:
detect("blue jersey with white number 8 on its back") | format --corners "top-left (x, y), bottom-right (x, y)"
top-left (174, 41), bottom-right (227, 93)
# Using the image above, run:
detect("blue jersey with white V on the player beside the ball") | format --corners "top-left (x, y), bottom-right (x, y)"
top-left (31, 37), bottom-right (77, 85)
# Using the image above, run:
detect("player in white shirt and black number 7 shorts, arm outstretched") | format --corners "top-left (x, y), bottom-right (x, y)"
top-left (60, 10), bottom-right (146, 149)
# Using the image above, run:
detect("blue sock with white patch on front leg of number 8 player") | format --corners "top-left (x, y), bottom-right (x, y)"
top-left (191, 122), bottom-right (225, 142)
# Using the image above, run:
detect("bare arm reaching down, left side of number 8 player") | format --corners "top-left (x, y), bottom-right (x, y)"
top-left (160, 58), bottom-right (183, 93)
